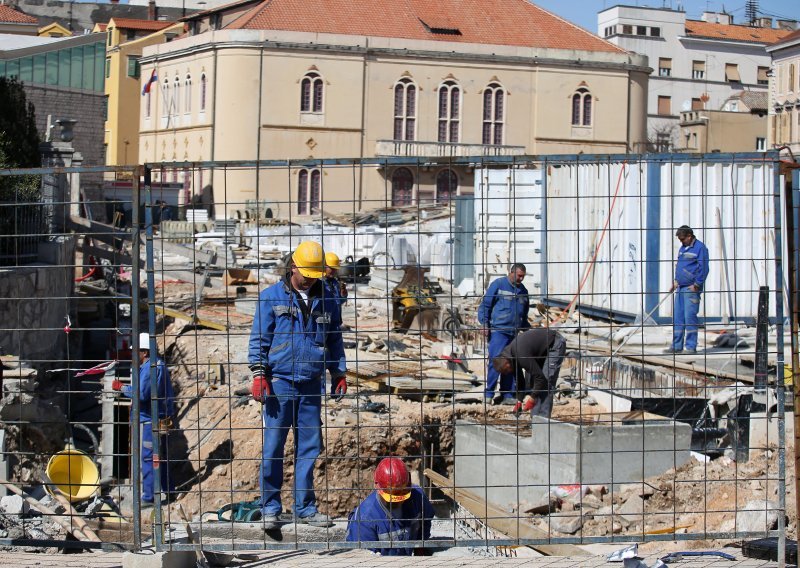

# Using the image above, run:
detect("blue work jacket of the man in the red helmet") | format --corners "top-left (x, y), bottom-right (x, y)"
top-left (346, 485), bottom-right (434, 556)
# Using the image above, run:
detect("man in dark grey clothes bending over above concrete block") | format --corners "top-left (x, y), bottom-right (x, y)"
top-left (492, 327), bottom-right (567, 418)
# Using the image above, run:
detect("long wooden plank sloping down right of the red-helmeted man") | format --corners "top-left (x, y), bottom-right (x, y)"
top-left (425, 468), bottom-right (589, 556)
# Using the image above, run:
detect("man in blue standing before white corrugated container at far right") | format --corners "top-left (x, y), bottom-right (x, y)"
top-left (665, 225), bottom-right (708, 353)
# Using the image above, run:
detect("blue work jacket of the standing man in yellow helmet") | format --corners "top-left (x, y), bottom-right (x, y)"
top-left (247, 276), bottom-right (347, 382)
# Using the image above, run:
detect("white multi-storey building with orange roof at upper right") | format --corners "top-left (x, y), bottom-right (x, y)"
top-left (597, 5), bottom-right (797, 151)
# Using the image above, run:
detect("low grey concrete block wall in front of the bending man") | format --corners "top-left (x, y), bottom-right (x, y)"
top-left (455, 417), bottom-right (692, 508)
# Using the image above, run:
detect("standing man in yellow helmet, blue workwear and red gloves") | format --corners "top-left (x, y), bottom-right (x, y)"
top-left (248, 241), bottom-right (347, 530)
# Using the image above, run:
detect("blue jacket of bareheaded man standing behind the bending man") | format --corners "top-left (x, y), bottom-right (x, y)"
top-left (478, 276), bottom-right (531, 336)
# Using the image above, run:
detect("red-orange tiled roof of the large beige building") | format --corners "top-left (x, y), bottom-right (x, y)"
top-left (227, 0), bottom-right (624, 53)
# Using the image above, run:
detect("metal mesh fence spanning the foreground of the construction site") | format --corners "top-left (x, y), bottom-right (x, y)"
top-left (0, 153), bottom-right (796, 555)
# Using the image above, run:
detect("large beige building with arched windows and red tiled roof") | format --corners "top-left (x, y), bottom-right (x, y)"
top-left (139, 0), bottom-right (650, 215)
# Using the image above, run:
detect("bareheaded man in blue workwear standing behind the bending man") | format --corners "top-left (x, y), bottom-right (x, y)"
top-left (478, 263), bottom-right (531, 404)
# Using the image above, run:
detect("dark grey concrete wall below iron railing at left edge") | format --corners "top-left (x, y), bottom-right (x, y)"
top-left (0, 239), bottom-right (75, 367)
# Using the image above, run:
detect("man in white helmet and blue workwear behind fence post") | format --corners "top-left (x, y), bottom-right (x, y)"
top-left (111, 333), bottom-right (176, 506)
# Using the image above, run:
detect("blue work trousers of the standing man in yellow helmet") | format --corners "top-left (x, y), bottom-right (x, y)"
top-left (261, 379), bottom-right (322, 517)
